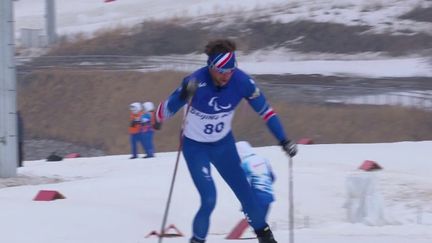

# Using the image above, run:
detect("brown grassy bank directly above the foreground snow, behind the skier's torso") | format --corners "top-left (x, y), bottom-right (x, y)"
top-left (18, 69), bottom-right (432, 154)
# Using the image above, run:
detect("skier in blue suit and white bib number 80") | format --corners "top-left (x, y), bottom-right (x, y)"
top-left (156, 39), bottom-right (297, 243)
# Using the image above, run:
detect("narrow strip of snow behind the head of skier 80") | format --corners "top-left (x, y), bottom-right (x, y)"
top-left (142, 52), bottom-right (432, 78)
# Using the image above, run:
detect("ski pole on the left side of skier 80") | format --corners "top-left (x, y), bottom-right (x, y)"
top-left (158, 97), bottom-right (192, 243)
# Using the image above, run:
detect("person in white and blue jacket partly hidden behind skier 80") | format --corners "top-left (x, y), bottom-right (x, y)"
top-left (236, 141), bottom-right (275, 219)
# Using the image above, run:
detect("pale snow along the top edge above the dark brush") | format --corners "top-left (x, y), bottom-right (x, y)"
top-left (15, 0), bottom-right (432, 34)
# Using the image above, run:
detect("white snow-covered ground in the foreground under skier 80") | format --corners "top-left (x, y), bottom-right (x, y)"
top-left (0, 141), bottom-right (432, 243)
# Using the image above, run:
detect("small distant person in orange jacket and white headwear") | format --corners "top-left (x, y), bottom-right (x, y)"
top-left (128, 102), bottom-right (144, 159)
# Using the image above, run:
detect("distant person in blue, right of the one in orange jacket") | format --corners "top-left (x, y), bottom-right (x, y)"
top-left (141, 101), bottom-right (154, 158)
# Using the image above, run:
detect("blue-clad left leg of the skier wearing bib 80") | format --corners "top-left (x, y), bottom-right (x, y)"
top-left (183, 138), bottom-right (216, 241)
